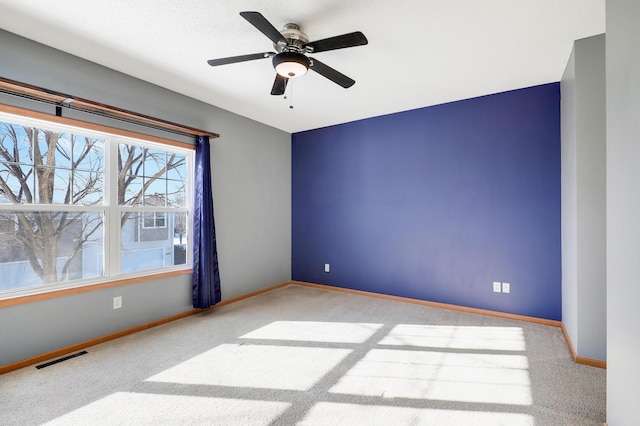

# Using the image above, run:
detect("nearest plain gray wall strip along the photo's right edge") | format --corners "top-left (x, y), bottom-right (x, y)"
top-left (606, 0), bottom-right (640, 426)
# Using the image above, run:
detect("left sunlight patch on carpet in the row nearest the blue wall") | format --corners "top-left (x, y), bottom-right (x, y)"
top-left (240, 321), bottom-right (382, 343)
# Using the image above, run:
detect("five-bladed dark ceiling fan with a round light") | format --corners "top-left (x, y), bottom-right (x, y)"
top-left (207, 12), bottom-right (368, 95)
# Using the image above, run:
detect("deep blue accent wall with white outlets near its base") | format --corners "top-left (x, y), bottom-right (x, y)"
top-left (292, 83), bottom-right (561, 320)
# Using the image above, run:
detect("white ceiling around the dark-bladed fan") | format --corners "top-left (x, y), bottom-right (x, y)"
top-left (0, 0), bottom-right (605, 132)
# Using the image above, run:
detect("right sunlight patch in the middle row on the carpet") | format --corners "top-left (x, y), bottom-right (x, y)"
top-left (330, 349), bottom-right (532, 405)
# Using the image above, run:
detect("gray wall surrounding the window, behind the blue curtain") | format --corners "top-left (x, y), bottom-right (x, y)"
top-left (0, 30), bottom-right (291, 365)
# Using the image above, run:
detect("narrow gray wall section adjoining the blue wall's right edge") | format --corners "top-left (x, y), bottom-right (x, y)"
top-left (560, 34), bottom-right (607, 360)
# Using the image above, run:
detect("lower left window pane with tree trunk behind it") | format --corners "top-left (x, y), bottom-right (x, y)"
top-left (0, 211), bottom-right (104, 291)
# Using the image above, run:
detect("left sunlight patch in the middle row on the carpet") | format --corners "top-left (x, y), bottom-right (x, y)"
top-left (147, 343), bottom-right (351, 390)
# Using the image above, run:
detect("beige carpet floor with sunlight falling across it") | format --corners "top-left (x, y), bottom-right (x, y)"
top-left (0, 285), bottom-right (606, 426)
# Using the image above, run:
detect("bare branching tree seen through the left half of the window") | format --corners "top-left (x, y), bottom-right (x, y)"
top-left (0, 123), bottom-right (104, 283)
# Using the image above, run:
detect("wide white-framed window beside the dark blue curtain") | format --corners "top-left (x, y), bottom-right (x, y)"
top-left (0, 113), bottom-right (193, 297)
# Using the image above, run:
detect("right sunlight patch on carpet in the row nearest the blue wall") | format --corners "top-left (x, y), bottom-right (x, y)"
top-left (379, 324), bottom-right (526, 351)
